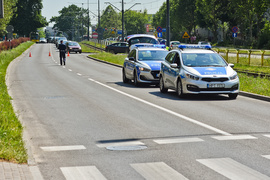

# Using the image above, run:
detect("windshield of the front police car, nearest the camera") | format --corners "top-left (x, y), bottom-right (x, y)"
top-left (182, 53), bottom-right (227, 67)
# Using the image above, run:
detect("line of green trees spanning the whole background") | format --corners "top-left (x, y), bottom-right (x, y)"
top-left (0, 0), bottom-right (270, 49)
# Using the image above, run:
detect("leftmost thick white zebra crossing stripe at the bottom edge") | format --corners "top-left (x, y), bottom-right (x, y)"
top-left (60, 166), bottom-right (106, 180)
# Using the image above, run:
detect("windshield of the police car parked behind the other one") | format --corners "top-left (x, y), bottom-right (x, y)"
top-left (138, 50), bottom-right (168, 61)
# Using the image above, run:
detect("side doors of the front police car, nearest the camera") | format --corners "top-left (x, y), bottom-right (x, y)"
top-left (161, 51), bottom-right (176, 88)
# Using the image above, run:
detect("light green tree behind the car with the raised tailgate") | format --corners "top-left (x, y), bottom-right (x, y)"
top-left (124, 10), bottom-right (149, 34)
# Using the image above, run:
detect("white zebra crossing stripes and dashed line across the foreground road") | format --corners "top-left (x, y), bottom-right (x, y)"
top-left (40, 135), bottom-right (270, 180)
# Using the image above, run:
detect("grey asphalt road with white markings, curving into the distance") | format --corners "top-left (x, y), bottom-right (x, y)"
top-left (8, 44), bottom-right (270, 180)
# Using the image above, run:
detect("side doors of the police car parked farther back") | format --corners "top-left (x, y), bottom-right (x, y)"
top-left (125, 49), bottom-right (136, 79)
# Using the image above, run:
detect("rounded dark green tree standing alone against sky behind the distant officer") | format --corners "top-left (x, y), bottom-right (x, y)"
top-left (50, 4), bottom-right (90, 39)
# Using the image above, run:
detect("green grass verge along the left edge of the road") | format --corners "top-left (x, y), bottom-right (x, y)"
top-left (0, 42), bottom-right (33, 163)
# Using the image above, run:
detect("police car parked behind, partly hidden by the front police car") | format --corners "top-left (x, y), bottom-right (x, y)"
top-left (122, 44), bottom-right (168, 86)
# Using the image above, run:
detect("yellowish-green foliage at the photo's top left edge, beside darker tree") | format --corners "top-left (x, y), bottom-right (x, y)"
top-left (0, 0), bottom-right (17, 37)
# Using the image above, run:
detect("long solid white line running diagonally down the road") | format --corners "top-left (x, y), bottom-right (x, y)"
top-left (88, 78), bottom-right (231, 136)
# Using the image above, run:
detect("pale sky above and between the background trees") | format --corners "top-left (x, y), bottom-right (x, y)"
top-left (41, 0), bottom-right (166, 26)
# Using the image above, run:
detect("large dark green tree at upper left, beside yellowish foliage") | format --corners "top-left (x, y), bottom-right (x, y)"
top-left (11, 0), bottom-right (48, 36)
